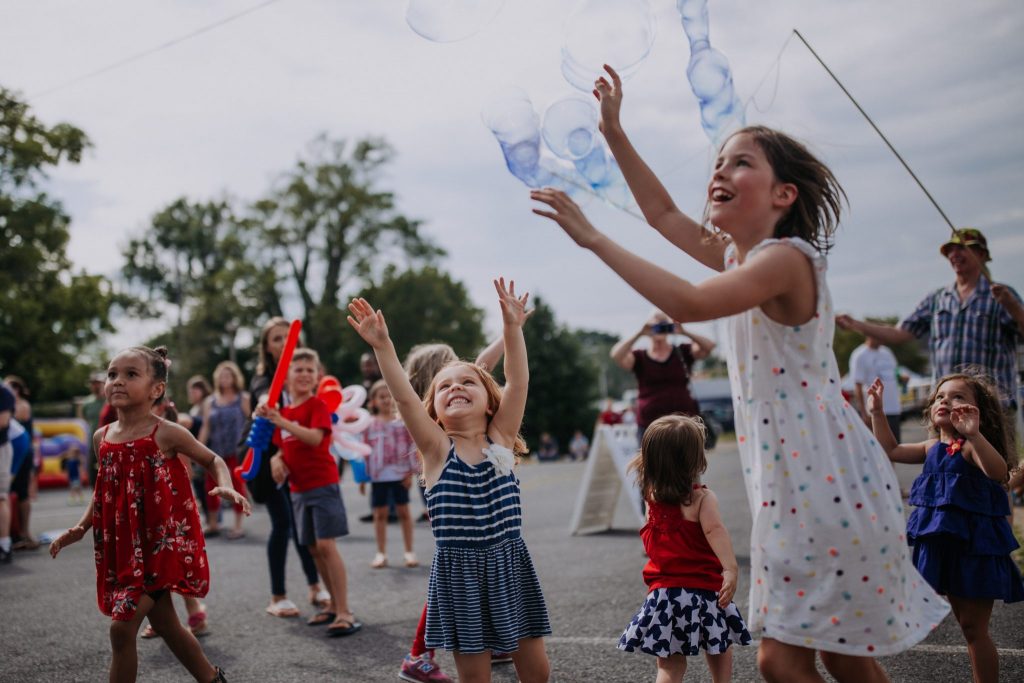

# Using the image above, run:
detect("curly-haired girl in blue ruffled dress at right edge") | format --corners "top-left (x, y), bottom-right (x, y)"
top-left (867, 374), bottom-right (1024, 681)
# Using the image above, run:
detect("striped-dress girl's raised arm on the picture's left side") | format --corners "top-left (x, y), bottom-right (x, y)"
top-left (348, 298), bottom-right (449, 471)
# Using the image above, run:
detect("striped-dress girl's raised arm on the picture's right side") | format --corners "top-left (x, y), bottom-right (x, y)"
top-left (490, 278), bottom-right (529, 447)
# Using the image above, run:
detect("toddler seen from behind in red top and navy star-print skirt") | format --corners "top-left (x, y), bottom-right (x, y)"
top-left (618, 415), bottom-right (751, 683)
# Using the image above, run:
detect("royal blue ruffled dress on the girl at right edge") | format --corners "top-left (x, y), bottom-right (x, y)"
top-left (906, 441), bottom-right (1024, 602)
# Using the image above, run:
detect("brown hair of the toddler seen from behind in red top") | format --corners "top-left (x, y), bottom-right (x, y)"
top-left (629, 415), bottom-right (708, 505)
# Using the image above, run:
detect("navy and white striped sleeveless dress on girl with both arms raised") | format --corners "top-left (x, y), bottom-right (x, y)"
top-left (426, 443), bottom-right (551, 654)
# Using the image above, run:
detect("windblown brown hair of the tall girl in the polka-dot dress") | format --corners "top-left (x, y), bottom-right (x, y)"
top-left (702, 126), bottom-right (847, 254)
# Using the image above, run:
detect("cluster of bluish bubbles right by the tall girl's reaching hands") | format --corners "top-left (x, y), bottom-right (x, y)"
top-left (481, 88), bottom-right (632, 209)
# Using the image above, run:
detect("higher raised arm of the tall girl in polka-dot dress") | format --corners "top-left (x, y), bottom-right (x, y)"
top-left (594, 65), bottom-right (726, 270)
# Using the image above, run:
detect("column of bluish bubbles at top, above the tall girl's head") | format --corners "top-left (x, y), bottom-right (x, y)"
top-left (676, 0), bottom-right (745, 144)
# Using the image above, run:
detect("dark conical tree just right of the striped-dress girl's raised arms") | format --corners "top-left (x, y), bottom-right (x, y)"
top-left (496, 296), bottom-right (598, 451)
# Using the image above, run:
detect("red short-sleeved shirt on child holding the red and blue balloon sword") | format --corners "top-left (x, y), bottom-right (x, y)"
top-left (273, 396), bottom-right (338, 493)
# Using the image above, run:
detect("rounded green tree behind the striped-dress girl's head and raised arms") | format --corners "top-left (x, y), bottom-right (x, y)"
top-left (328, 265), bottom-right (486, 378)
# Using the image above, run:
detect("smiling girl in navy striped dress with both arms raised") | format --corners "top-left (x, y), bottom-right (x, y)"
top-left (348, 279), bottom-right (551, 683)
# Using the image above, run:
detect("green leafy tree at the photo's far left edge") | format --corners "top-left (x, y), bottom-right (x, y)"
top-left (0, 88), bottom-right (112, 400)
